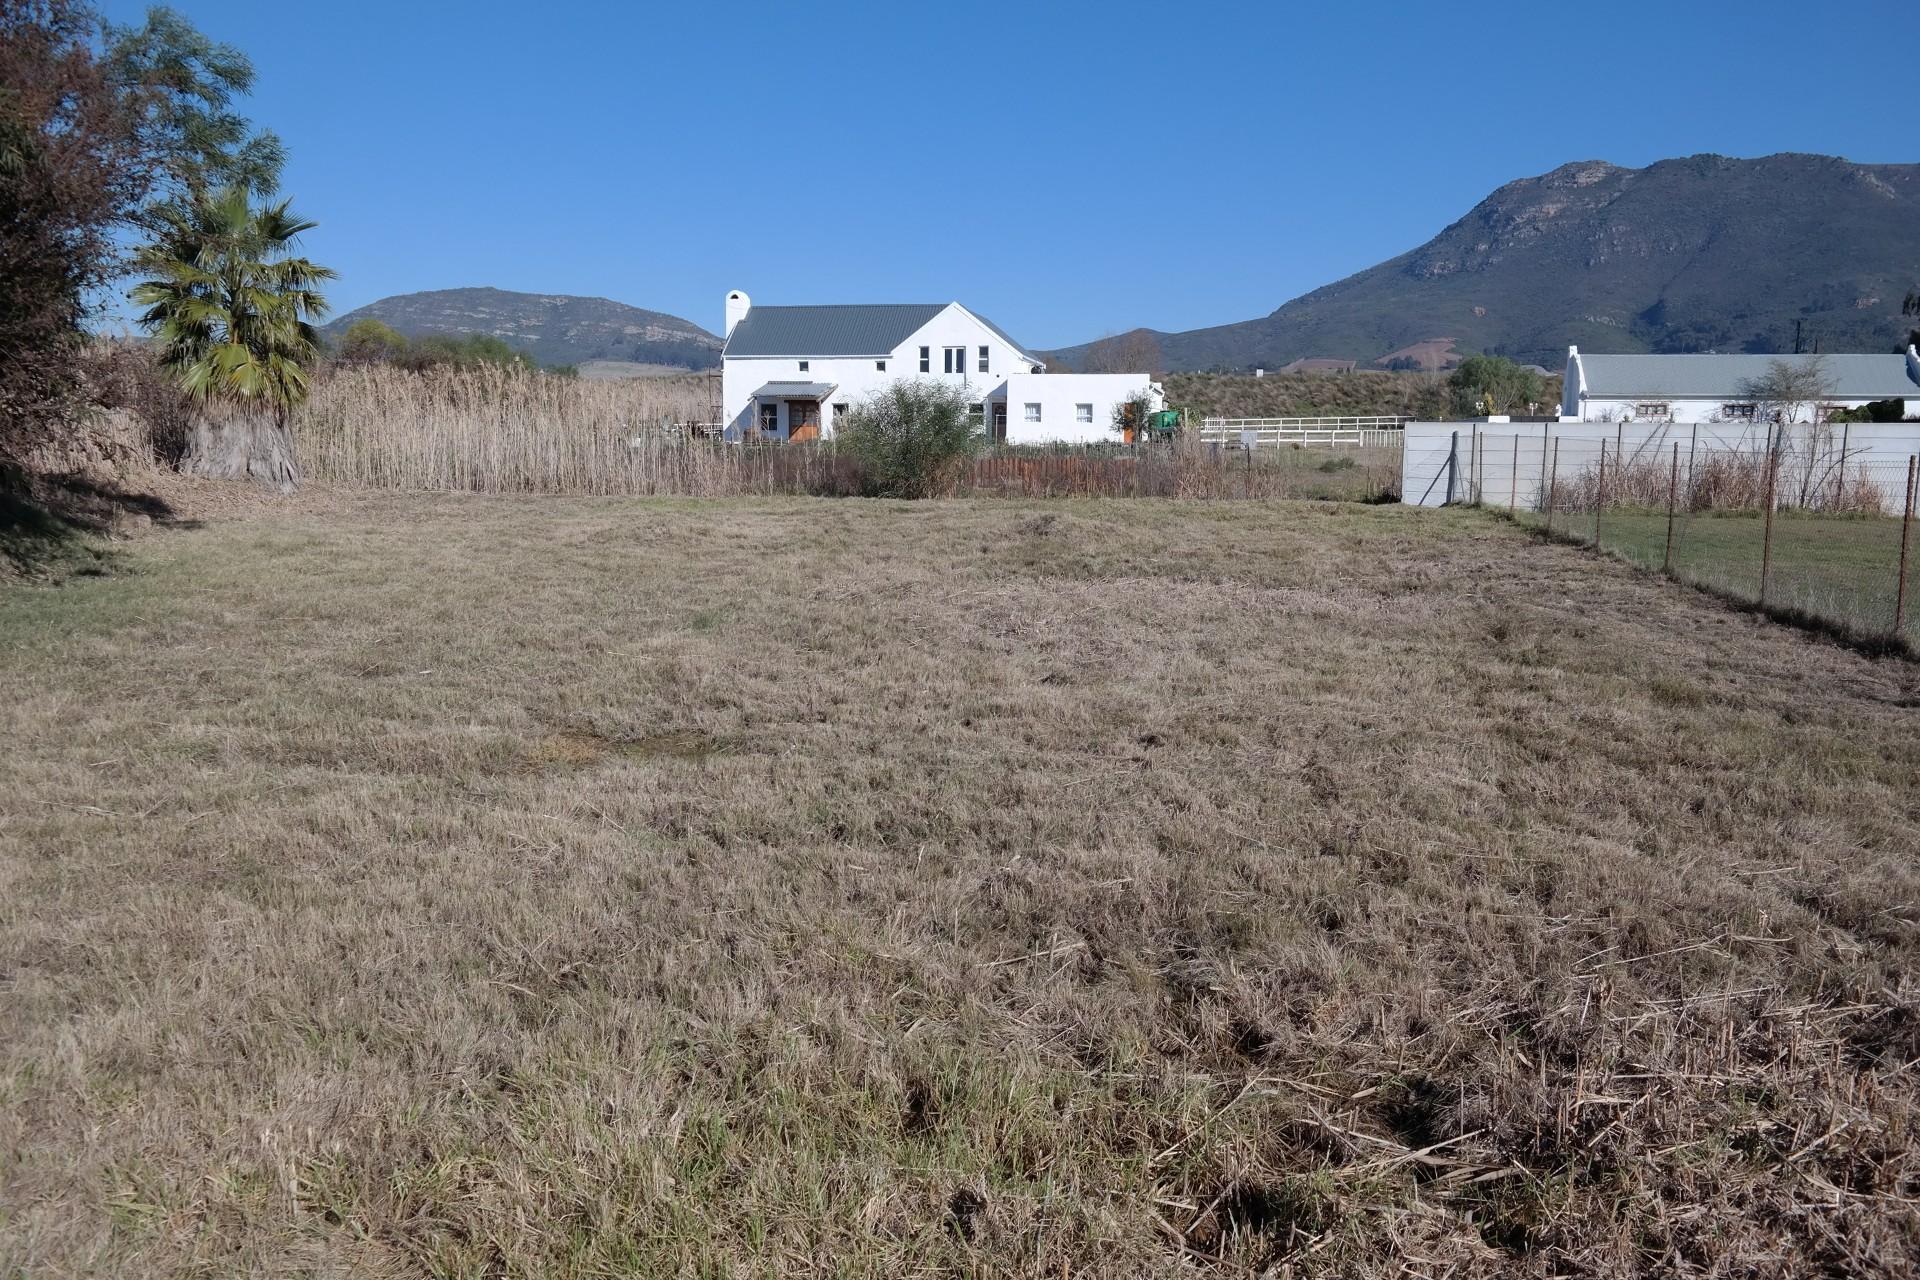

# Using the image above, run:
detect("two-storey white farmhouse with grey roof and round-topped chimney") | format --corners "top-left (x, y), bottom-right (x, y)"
top-left (722, 290), bottom-right (1165, 445)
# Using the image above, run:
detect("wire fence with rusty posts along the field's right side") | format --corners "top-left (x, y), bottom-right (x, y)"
top-left (1436, 422), bottom-right (1920, 647)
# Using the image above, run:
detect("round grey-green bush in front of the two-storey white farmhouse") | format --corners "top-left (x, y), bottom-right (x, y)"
top-left (833, 378), bottom-right (983, 497)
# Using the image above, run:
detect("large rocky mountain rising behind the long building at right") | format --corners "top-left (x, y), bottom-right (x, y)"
top-left (1046, 155), bottom-right (1920, 370)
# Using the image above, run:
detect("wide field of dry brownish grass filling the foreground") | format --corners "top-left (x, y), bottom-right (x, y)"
top-left (0, 495), bottom-right (1920, 1278)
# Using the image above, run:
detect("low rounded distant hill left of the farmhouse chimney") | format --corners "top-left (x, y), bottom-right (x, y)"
top-left (324, 288), bottom-right (720, 368)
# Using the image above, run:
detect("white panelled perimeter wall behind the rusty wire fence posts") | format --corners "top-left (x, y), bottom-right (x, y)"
top-left (1400, 422), bottom-right (1920, 510)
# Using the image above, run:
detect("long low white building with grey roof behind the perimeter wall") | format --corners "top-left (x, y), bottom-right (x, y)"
top-left (1561, 347), bottom-right (1920, 422)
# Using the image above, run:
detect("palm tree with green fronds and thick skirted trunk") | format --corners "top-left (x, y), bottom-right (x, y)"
top-left (132, 186), bottom-right (334, 493)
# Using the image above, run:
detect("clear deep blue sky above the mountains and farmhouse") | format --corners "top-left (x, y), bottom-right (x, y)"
top-left (106, 0), bottom-right (1920, 347)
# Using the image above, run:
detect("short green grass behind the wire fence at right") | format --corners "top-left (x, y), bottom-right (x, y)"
top-left (1519, 510), bottom-right (1920, 643)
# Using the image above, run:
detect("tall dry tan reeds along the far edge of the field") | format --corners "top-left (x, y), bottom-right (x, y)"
top-left (294, 367), bottom-right (1398, 499)
